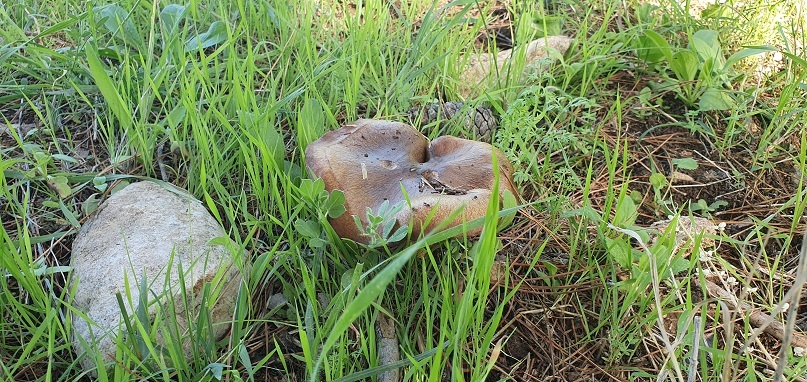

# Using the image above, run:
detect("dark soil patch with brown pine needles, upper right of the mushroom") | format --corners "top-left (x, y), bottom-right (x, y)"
top-left (603, 72), bottom-right (805, 243)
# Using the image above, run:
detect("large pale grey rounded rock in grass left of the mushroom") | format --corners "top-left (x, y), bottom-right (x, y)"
top-left (70, 182), bottom-right (243, 371)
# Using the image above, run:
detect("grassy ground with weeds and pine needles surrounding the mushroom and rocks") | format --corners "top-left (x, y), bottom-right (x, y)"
top-left (0, 0), bottom-right (807, 381)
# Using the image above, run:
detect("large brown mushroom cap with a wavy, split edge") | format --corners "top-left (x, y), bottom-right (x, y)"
top-left (305, 119), bottom-right (517, 243)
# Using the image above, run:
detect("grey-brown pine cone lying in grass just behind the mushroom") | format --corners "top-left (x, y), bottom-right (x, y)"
top-left (407, 102), bottom-right (499, 141)
